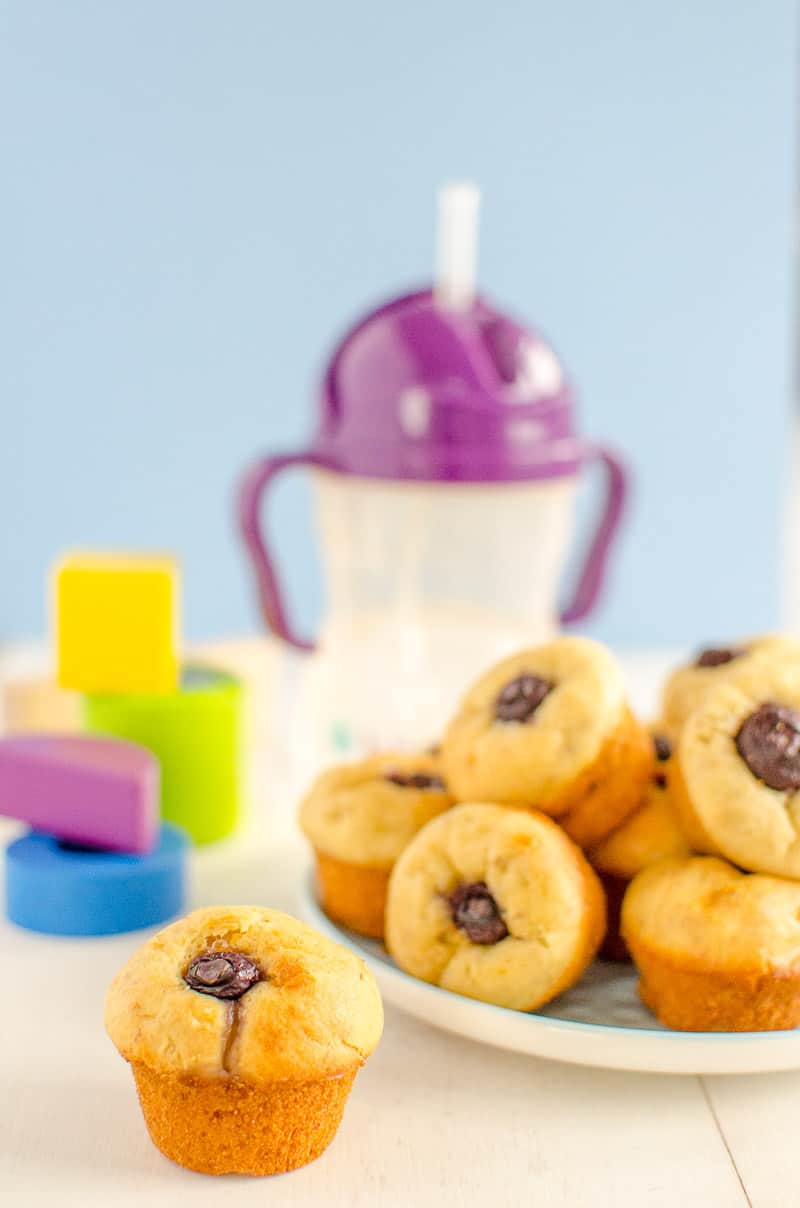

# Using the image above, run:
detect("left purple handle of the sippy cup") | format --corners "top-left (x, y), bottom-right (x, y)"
top-left (238, 453), bottom-right (319, 651)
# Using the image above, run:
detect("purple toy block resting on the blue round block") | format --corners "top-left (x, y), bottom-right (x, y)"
top-left (0, 734), bottom-right (161, 853)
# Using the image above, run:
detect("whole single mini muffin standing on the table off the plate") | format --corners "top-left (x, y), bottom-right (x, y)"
top-left (105, 906), bottom-right (383, 1174)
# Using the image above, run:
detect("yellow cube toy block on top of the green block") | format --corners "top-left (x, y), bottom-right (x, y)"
top-left (53, 553), bottom-right (179, 692)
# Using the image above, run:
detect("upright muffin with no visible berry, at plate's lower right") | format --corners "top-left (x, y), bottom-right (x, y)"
top-left (622, 856), bottom-right (800, 1032)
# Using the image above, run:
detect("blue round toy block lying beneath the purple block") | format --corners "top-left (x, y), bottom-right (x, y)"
top-left (6, 823), bottom-right (189, 935)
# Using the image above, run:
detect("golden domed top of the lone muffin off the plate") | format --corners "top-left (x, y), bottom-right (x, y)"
top-left (105, 906), bottom-right (383, 1084)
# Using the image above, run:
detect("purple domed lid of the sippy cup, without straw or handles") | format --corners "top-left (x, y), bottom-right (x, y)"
top-left (313, 290), bottom-right (580, 482)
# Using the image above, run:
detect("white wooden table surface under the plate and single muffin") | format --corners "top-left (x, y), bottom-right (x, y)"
top-left (0, 663), bottom-right (800, 1208)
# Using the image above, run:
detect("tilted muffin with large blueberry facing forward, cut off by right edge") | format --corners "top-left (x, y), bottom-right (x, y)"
top-left (672, 668), bottom-right (800, 879)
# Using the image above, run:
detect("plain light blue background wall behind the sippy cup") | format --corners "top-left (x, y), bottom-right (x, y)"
top-left (0, 0), bottom-right (795, 645)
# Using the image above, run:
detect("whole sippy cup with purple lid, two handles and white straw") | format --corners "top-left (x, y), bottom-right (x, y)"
top-left (239, 185), bottom-right (625, 762)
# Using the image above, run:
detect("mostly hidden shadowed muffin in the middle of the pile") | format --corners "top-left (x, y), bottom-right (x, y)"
top-left (589, 733), bottom-right (690, 960)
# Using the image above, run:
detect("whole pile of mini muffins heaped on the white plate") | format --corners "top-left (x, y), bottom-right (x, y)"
top-left (300, 637), bottom-right (800, 1030)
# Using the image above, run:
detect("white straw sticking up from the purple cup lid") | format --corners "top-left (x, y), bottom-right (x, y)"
top-left (434, 181), bottom-right (481, 310)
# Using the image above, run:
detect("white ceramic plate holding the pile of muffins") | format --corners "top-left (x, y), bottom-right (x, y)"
top-left (302, 877), bottom-right (800, 1074)
